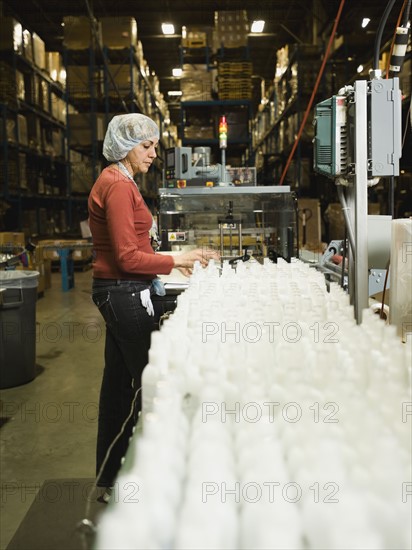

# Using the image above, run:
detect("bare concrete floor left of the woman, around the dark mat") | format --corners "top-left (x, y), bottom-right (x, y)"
top-left (0, 270), bottom-right (104, 549)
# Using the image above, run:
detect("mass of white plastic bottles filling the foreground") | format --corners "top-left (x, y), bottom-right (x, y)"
top-left (96, 262), bottom-right (412, 550)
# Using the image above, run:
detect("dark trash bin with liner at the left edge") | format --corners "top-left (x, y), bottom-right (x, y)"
top-left (0, 270), bottom-right (39, 389)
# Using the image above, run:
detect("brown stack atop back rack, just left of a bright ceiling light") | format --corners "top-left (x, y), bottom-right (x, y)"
top-left (214, 10), bottom-right (249, 48)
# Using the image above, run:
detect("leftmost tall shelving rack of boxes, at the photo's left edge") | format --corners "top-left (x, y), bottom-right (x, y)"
top-left (0, 49), bottom-right (70, 235)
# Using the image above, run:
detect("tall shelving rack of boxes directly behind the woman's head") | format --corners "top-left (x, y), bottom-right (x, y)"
top-left (64, 45), bottom-right (175, 209)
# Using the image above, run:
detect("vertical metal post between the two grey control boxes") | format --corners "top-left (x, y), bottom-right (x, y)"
top-left (354, 80), bottom-right (369, 324)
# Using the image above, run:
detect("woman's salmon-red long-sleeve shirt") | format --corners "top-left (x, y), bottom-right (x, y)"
top-left (88, 166), bottom-right (174, 280)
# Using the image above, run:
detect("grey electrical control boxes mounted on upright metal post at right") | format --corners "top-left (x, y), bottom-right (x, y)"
top-left (314, 75), bottom-right (402, 323)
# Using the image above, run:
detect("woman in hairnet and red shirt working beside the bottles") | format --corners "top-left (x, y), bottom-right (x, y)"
top-left (88, 113), bottom-right (218, 496)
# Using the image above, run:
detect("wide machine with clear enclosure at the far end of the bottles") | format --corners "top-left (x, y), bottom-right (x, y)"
top-left (158, 186), bottom-right (298, 261)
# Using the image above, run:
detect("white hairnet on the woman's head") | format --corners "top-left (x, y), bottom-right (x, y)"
top-left (103, 113), bottom-right (159, 162)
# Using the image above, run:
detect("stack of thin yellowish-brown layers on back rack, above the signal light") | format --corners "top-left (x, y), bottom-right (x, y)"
top-left (218, 61), bottom-right (252, 100)
